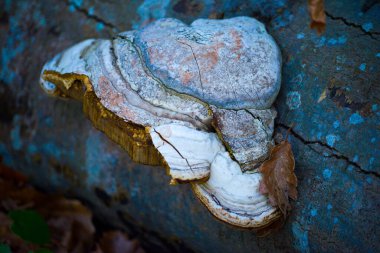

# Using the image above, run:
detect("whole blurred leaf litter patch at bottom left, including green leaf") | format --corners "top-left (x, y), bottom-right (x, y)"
top-left (0, 161), bottom-right (144, 253)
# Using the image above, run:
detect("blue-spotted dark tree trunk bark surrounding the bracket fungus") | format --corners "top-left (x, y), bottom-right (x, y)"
top-left (0, 0), bottom-right (380, 252)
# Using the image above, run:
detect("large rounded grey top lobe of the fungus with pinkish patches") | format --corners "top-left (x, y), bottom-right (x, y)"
top-left (134, 17), bottom-right (281, 109)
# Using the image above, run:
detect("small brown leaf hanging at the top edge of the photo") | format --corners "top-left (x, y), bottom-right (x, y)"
top-left (308, 0), bottom-right (326, 34)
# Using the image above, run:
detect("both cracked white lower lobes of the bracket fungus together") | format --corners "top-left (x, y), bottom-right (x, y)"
top-left (150, 125), bottom-right (276, 227)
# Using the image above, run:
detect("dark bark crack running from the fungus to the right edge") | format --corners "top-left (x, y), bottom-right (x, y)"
top-left (276, 123), bottom-right (380, 178)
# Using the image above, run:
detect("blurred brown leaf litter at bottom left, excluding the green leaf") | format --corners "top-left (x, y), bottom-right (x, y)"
top-left (0, 157), bottom-right (144, 253)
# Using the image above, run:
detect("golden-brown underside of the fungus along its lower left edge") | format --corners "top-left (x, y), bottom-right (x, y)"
top-left (42, 70), bottom-right (164, 165)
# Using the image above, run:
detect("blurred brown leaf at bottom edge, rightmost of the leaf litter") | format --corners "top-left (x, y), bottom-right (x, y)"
top-left (99, 231), bottom-right (145, 253)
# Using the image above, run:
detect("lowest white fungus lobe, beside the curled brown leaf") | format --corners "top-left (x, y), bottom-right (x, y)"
top-left (193, 152), bottom-right (277, 227)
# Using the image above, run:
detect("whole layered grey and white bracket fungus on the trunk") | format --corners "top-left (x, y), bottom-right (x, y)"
top-left (41, 17), bottom-right (290, 229)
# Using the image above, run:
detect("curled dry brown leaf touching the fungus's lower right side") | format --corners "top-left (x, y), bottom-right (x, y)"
top-left (259, 140), bottom-right (297, 217)
